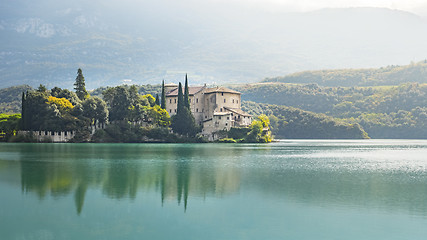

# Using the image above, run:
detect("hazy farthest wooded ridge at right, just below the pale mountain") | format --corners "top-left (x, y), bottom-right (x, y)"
top-left (264, 60), bottom-right (427, 87)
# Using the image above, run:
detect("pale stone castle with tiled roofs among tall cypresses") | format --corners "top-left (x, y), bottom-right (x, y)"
top-left (165, 84), bottom-right (252, 140)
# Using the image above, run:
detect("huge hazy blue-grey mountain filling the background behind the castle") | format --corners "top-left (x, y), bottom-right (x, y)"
top-left (0, 0), bottom-right (427, 89)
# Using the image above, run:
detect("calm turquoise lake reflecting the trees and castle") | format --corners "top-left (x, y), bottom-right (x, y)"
top-left (0, 140), bottom-right (427, 240)
